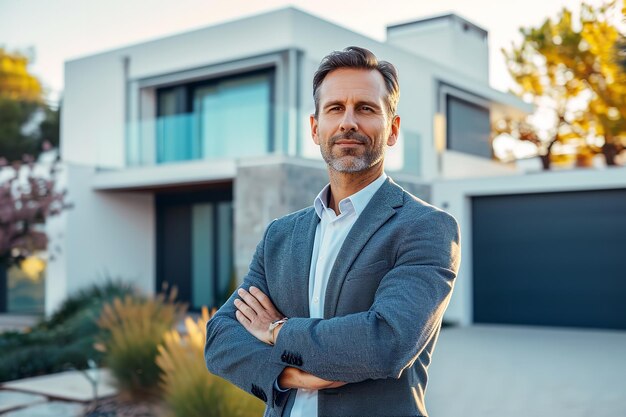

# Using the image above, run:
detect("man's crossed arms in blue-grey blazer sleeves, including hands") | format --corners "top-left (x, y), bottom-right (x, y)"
top-left (205, 212), bottom-right (459, 393)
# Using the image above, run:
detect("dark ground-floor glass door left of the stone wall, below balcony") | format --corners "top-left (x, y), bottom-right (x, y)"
top-left (156, 189), bottom-right (234, 310)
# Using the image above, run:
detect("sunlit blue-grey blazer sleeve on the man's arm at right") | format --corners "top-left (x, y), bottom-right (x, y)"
top-left (272, 210), bottom-right (460, 383)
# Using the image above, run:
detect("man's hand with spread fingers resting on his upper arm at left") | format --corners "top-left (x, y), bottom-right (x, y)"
top-left (235, 287), bottom-right (285, 344)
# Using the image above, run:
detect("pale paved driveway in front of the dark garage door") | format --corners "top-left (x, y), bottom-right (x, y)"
top-left (426, 325), bottom-right (626, 417)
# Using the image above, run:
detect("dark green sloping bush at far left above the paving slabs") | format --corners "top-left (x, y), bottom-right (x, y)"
top-left (0, 280), bottom-right (134, 382)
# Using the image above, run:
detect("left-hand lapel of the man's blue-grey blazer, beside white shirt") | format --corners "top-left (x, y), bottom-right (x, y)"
top-left (290, 210), bottom-right (319, 317)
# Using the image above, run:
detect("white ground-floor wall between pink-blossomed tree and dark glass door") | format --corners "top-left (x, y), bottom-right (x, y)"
top-left (45, 164), bottom-right (155, 314)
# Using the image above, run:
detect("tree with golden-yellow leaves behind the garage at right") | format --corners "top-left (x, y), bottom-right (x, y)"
top-left (496, 2), bottom-right (626, 169)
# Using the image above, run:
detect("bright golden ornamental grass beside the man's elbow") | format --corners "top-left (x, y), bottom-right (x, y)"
top-left (156, 308), bottom-right (264, 417)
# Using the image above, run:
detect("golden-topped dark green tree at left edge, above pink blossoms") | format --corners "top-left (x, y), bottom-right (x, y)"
top-left (0, 48), bottom-right (59, 161)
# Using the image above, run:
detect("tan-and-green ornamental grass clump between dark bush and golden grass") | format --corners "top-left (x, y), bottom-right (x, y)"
top-left (98, 290), bottom-right (186, 398)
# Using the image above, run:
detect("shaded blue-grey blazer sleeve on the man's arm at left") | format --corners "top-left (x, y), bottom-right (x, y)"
top-left (204, 222), bottom-right (285, 407)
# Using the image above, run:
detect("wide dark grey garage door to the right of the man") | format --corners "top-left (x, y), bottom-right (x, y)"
top-left (472, 189), bottom-right (626, 329)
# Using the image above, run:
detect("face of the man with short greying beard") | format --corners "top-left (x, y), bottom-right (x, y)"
top-left (310, 68), bottom-right (400, 172)
